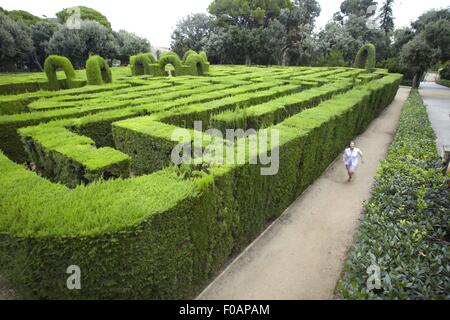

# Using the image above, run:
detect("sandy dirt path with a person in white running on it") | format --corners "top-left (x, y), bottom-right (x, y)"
top-left (198, 88), bottom-right (409, 300)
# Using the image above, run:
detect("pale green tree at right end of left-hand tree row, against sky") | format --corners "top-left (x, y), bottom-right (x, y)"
top-left (113, 30), bottom-right (151, 63)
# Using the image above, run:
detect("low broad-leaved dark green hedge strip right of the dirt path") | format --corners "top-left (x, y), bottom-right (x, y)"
top-left (337, 91), bottom-right (450, 300)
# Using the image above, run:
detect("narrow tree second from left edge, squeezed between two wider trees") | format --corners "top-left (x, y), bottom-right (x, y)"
top-left (31, 21), bottom-right (56, 71)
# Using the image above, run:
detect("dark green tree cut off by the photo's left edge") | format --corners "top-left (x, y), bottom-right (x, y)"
top-left (0, 13), bottom-right (33, 71)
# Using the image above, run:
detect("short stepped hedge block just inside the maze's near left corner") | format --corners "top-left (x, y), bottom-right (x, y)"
top-left (19, 123), bottom-right (130, 188)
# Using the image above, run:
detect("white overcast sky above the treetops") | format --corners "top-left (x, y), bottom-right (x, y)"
top-left (0, 0), bottom-right (450, 47)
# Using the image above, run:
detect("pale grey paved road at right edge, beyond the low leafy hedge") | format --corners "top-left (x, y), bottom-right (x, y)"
top-left (419, 82), bottom-right (450, 155)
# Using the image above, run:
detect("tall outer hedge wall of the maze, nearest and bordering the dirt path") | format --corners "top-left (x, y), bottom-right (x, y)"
top-left (0, 75), bottom-right (401, 299)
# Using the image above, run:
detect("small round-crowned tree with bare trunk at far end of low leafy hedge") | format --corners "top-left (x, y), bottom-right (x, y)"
top-left (401, 34), bottom-right (433, 88)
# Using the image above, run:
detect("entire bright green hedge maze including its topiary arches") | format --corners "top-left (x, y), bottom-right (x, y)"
top-left (0, 62), bottom-right (402, 299)
